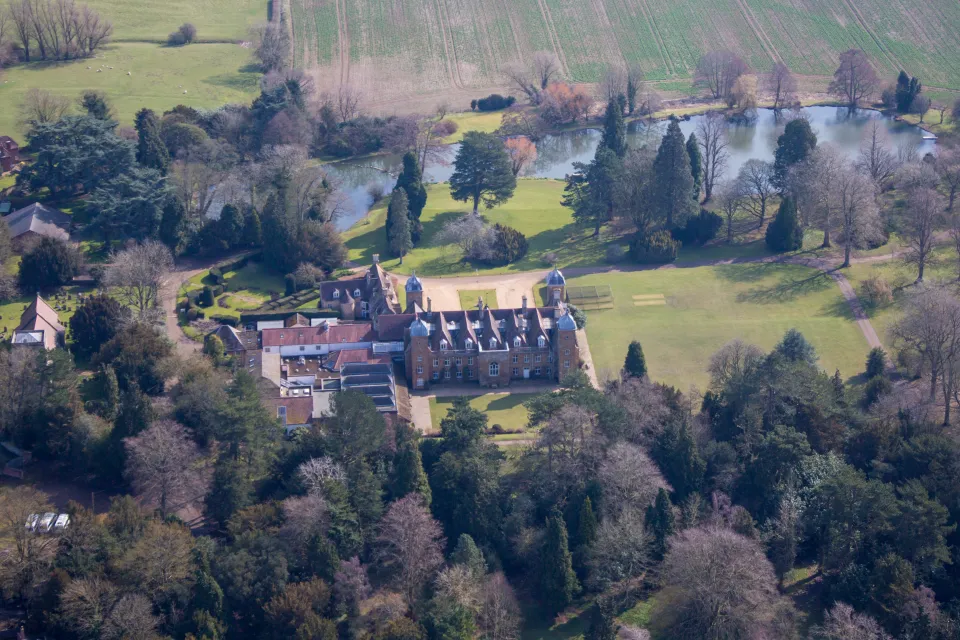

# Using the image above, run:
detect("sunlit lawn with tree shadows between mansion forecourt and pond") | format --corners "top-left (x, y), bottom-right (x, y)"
top-left (344, 179), bottom-right (615, 276)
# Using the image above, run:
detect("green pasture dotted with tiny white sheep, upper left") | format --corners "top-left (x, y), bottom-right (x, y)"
top-left (0, 41), bottom-right (260, 136)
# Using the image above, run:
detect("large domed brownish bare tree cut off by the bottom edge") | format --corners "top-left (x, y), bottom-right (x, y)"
top-left (652, 528), bottom-right (783, 640)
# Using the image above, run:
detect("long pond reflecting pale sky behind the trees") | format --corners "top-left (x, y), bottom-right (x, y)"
top-left (327, 107), bottom-right (935, 230)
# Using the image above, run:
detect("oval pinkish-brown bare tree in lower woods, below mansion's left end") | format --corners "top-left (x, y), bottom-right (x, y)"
top-left (376, 493), bottom-right (444, 607)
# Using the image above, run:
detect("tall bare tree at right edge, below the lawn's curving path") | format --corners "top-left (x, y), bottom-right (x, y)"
top-left (891, 286), bottom-right (960, 424)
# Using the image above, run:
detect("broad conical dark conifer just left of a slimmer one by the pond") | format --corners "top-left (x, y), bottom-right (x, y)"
top-left (653, 120), bottom-right (696, 229)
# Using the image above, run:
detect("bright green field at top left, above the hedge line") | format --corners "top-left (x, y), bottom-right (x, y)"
top-left (87, 0), bottom-right (267, 42)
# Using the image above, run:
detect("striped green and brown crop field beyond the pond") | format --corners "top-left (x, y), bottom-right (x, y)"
top-left (292, 0), bottom-right (960, 99)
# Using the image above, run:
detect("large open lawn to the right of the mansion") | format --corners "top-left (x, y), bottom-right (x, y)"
top-left (567, 264), bottom-right (869, 391)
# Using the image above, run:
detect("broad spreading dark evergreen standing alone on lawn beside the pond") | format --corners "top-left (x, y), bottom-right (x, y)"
top-left (450, 131), bottom-right (517, 215)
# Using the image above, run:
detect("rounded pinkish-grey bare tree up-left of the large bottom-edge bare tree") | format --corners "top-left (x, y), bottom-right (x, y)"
top-left (598, 442), bottom-right (670, 518)
